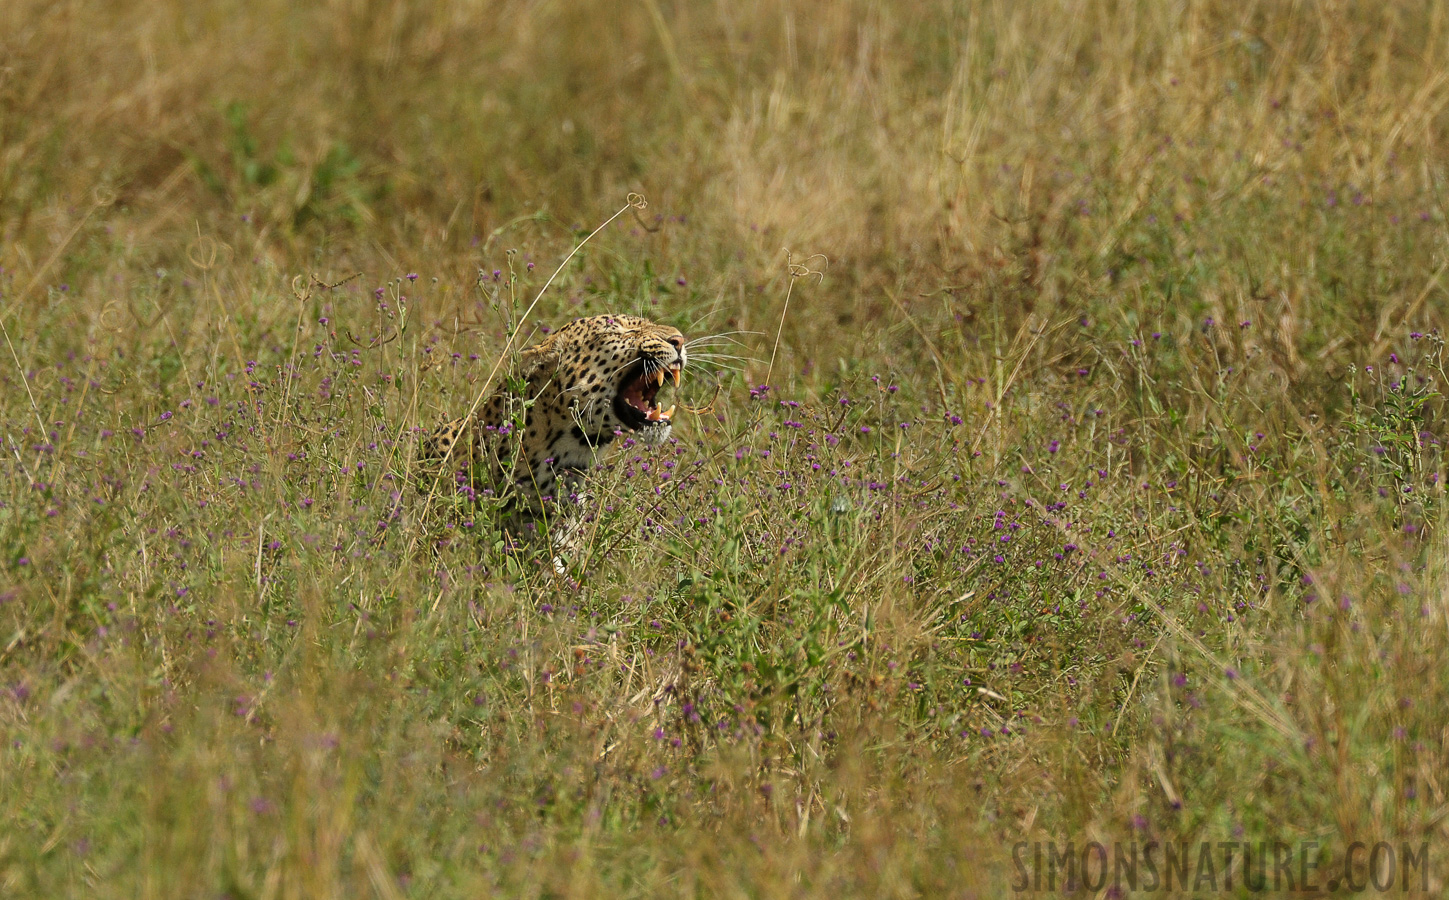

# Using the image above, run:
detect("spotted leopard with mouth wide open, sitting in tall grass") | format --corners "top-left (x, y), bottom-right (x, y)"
top-left (417, 314), bottom-right (688, 544)
